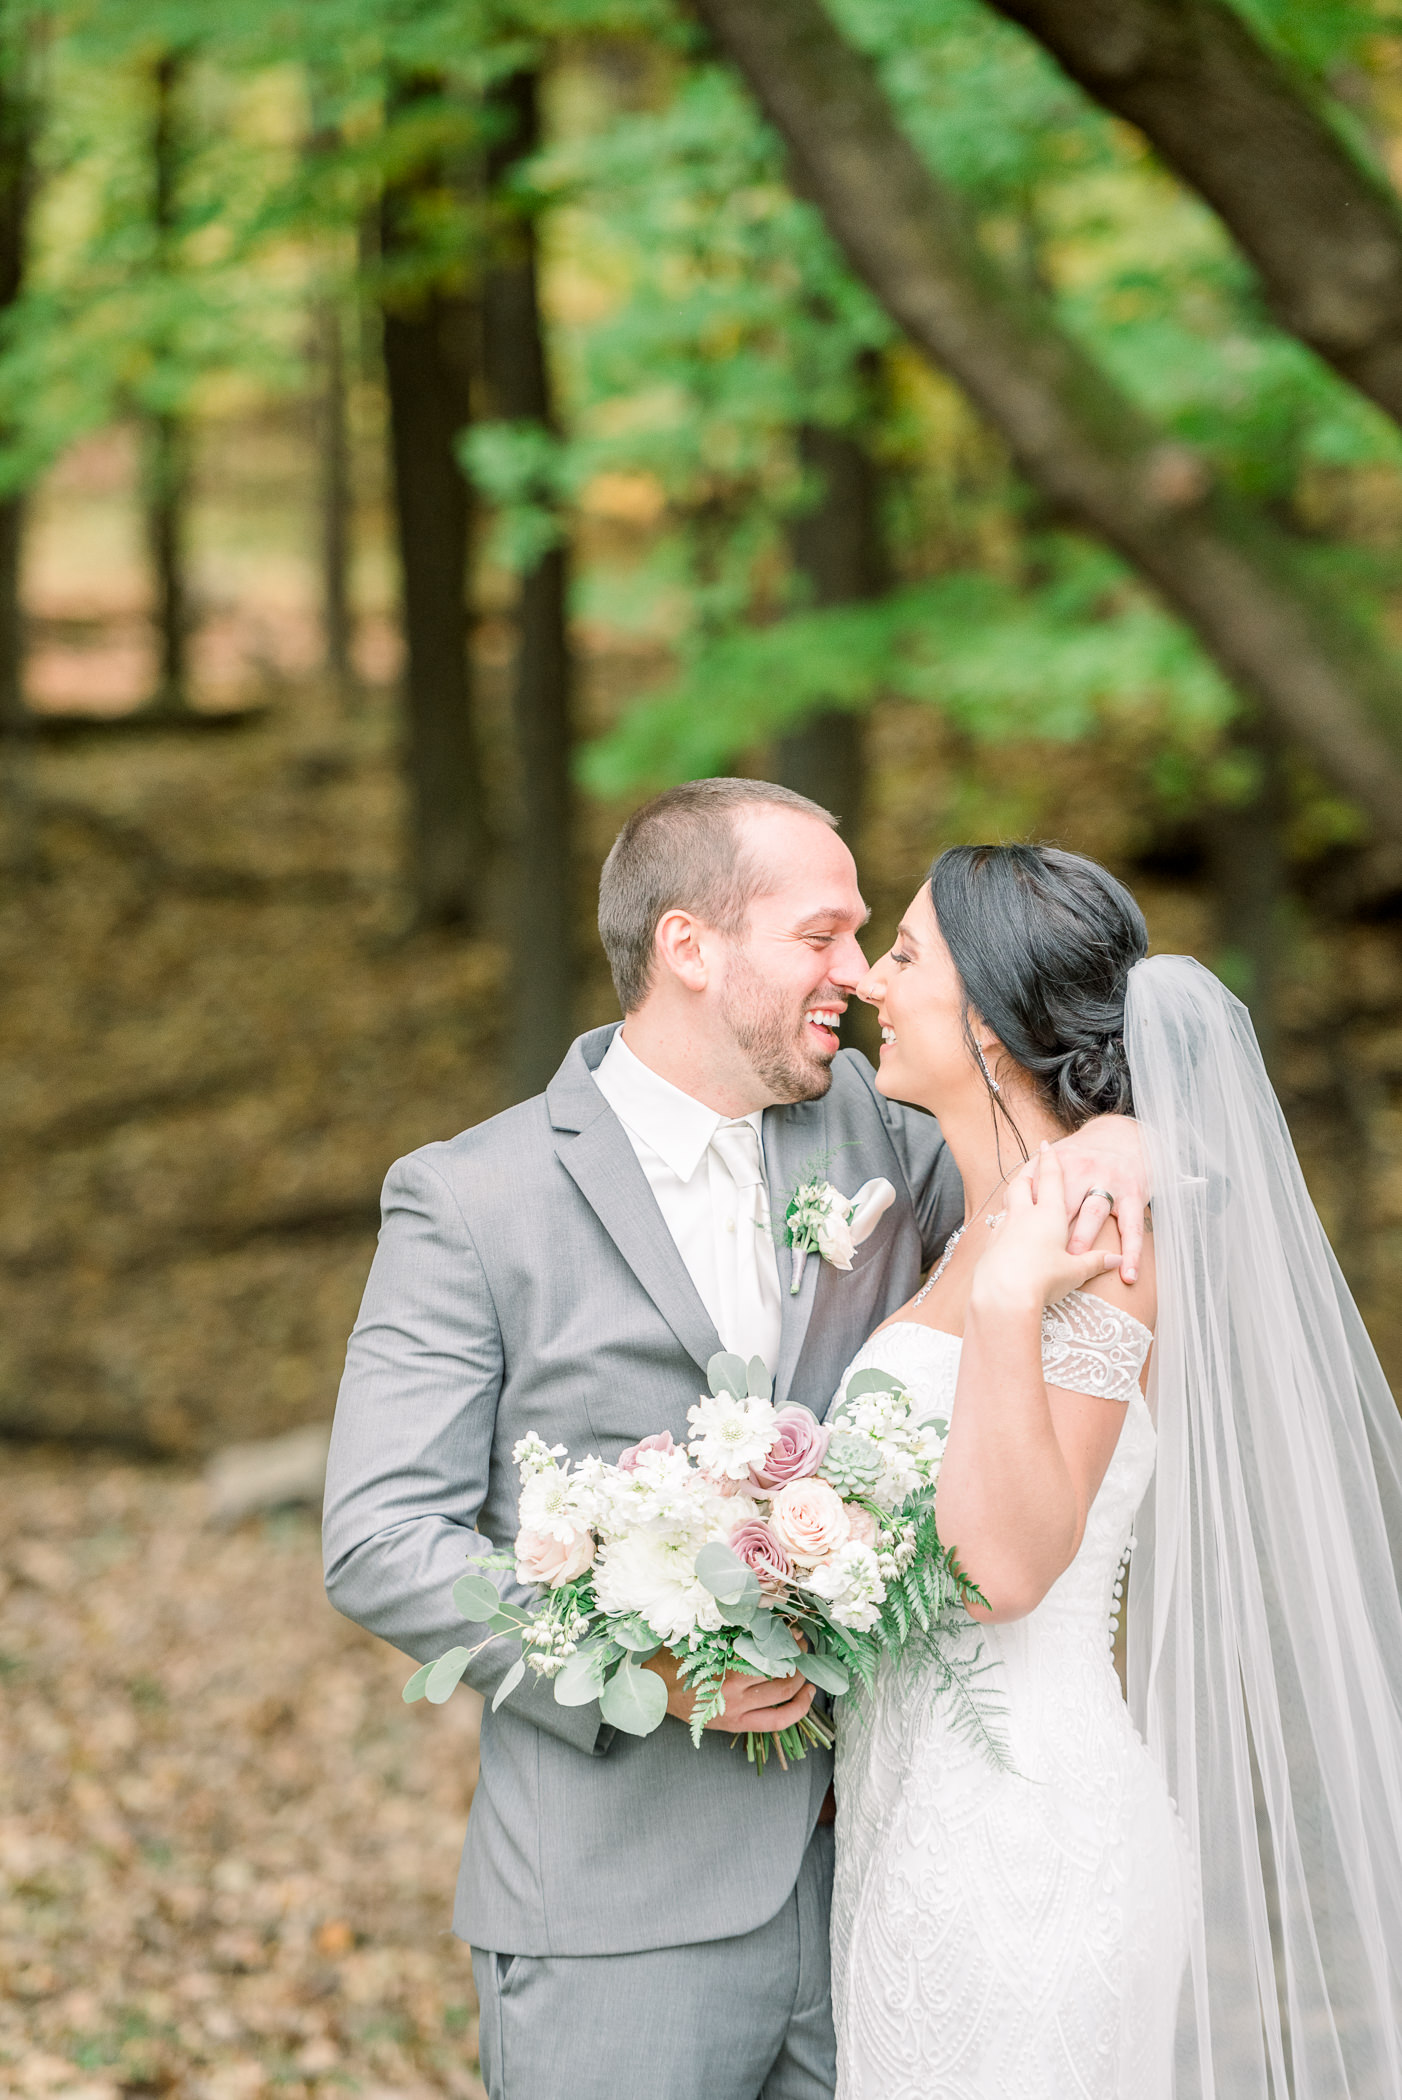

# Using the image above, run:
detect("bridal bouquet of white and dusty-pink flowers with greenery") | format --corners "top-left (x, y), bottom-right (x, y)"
top-left (403, 1355), bottom-right (993, 1768)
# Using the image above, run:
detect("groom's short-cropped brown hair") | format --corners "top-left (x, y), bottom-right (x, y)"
top-left (598, 779), bottom-right (837, 1014)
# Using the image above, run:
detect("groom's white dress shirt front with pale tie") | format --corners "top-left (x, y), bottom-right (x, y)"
top-left (594, 1031), bottom-right (781, 1376)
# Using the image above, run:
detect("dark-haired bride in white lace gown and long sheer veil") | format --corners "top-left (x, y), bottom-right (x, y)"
top-left (833, 846), bottom-right (1402, 2100)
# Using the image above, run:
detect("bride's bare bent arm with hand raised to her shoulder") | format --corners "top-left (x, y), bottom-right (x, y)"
top-left (936, 1151), bottom-right (1154, 1619)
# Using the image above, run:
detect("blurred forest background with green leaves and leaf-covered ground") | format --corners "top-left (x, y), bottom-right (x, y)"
top-left (0, 0), bottom-right (1402, 2094)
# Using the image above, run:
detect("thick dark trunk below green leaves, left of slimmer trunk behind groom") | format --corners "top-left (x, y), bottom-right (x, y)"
top-left (380, 82), bottom-right (487, 928)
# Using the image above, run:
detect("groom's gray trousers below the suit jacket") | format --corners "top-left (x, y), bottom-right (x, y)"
top-left (472, 1827), bottom-right (837, 2100)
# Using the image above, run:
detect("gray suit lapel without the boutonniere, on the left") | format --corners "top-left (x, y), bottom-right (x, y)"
top-left (546, 1029), bottom-right (722, 1369)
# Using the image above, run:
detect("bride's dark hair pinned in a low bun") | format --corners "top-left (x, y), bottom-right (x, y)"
top-left (930, 846), bottom-right (1148, 1130)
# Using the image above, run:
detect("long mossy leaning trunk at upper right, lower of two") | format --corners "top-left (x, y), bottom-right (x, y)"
top-left (695, 0), bottom-right (1402, 840)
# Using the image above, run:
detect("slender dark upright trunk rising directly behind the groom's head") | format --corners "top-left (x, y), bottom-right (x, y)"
top-left (483, 71), bottom-right (575, 1096)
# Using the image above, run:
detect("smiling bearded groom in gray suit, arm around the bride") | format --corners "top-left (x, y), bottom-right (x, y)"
top-left (325, 779), bottom-right (1142, 2100)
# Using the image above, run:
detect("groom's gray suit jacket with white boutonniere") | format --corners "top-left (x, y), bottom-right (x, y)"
top-left (325, 1029), bottom-right (963, 1955)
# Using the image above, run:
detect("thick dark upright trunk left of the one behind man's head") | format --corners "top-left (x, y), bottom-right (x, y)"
top-left (380, 71), bottom-right (489, 928)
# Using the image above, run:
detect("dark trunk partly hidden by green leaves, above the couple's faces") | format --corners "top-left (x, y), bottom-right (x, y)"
top-left (774, 424), bottom-right (890, 844)
